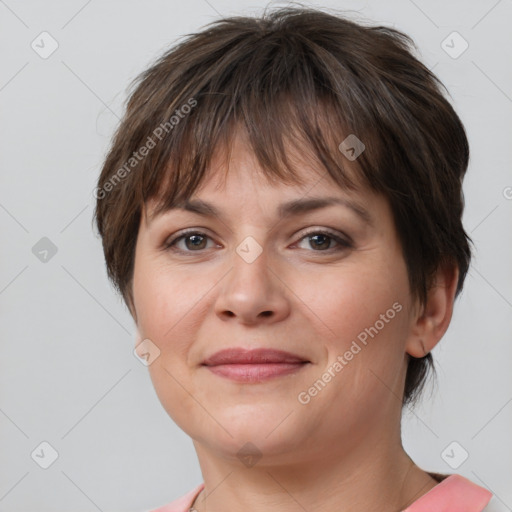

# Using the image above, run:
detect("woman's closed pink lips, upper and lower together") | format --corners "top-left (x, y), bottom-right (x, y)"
top-left (202, 348), bottom-right (309, 382)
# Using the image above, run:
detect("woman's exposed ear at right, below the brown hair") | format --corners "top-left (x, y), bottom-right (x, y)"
top-left (406, 265), bottom-right (459, 358)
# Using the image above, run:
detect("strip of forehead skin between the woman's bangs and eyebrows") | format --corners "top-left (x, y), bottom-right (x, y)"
top-left (145, 132), bottom-right (372, 221)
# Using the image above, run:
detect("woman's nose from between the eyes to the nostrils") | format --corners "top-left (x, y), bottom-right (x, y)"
top-left (215, 242), bottom-right (290, 325)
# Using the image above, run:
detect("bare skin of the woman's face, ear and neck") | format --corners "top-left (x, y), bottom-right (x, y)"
top-left (131, 133), bottom-right (457, 512)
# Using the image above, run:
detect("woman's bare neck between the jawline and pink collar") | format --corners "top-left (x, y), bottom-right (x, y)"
top-left (190, 430), bottom-right (438, 512)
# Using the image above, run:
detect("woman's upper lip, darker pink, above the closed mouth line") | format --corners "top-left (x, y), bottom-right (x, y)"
top-left (202, 348), bottom-right (309, 366)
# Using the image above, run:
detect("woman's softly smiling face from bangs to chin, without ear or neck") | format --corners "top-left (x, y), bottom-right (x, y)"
top-left (133, 135), bottom-right (418, 461)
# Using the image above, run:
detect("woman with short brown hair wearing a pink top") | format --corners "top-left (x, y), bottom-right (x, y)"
top-left (95, 8), bottom-right (491, 512)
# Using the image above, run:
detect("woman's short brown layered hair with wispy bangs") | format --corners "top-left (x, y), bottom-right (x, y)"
top-left (95, 7), bottom-right (471, 405)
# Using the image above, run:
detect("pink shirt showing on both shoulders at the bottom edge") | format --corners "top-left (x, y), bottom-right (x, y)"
top-left (148, 475), bottom-right (492, 512)
